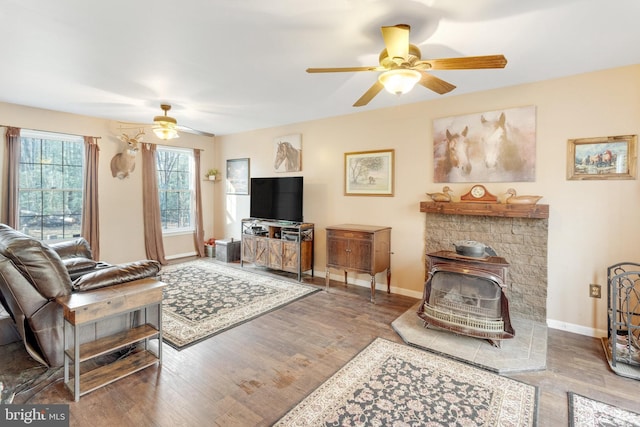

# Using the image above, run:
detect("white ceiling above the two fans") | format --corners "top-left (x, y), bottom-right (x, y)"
top-left (0, 0), bottom-right (640, 135)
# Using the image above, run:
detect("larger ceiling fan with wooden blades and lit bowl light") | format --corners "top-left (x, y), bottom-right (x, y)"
top-left (307, 24), bottom-right (507, 107)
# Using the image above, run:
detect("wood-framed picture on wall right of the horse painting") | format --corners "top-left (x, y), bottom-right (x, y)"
top-left (567, 135), bottom-right (638, 180)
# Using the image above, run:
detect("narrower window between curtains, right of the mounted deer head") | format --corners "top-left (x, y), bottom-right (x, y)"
top-left (156, 147), bottom-right (195, 233)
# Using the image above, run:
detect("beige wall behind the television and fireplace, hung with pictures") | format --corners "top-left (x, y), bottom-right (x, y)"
top-left (214, 65), bottom-right (640, 335)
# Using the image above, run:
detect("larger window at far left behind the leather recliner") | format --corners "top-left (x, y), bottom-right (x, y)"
top-left (18, 129), bottom-right (84, 240)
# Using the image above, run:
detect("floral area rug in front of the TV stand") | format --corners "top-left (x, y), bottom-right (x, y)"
top-left (160, 260), bottom-right (320, 350)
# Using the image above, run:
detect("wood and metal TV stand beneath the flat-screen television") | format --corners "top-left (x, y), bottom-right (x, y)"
top-left (240, 218), bottom-right (314, 281)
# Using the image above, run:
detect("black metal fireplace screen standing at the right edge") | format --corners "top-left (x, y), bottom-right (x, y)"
top-left (603, 262), bottom-right (640, 379)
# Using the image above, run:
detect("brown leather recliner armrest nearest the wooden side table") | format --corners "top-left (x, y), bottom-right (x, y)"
top-left (72, 260), bottom-right (160, 292)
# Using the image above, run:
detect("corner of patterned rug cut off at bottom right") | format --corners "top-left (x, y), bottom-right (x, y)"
top-left (568, 392), bottom-right (640, 427)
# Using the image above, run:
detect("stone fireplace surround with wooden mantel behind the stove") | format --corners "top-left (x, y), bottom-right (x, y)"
top-left (420, 202), bottom-right (549, 324)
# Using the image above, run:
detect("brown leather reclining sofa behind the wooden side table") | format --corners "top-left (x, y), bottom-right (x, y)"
top-left (0, 224), bottom-right (160, 367)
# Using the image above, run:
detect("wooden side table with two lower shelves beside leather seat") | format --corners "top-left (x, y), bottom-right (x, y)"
top-left (56, 278), bottom-right (165, 402)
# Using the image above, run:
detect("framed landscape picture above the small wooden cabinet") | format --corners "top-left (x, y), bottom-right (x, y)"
top-left (344, 150), bottom-right (395, 197)
